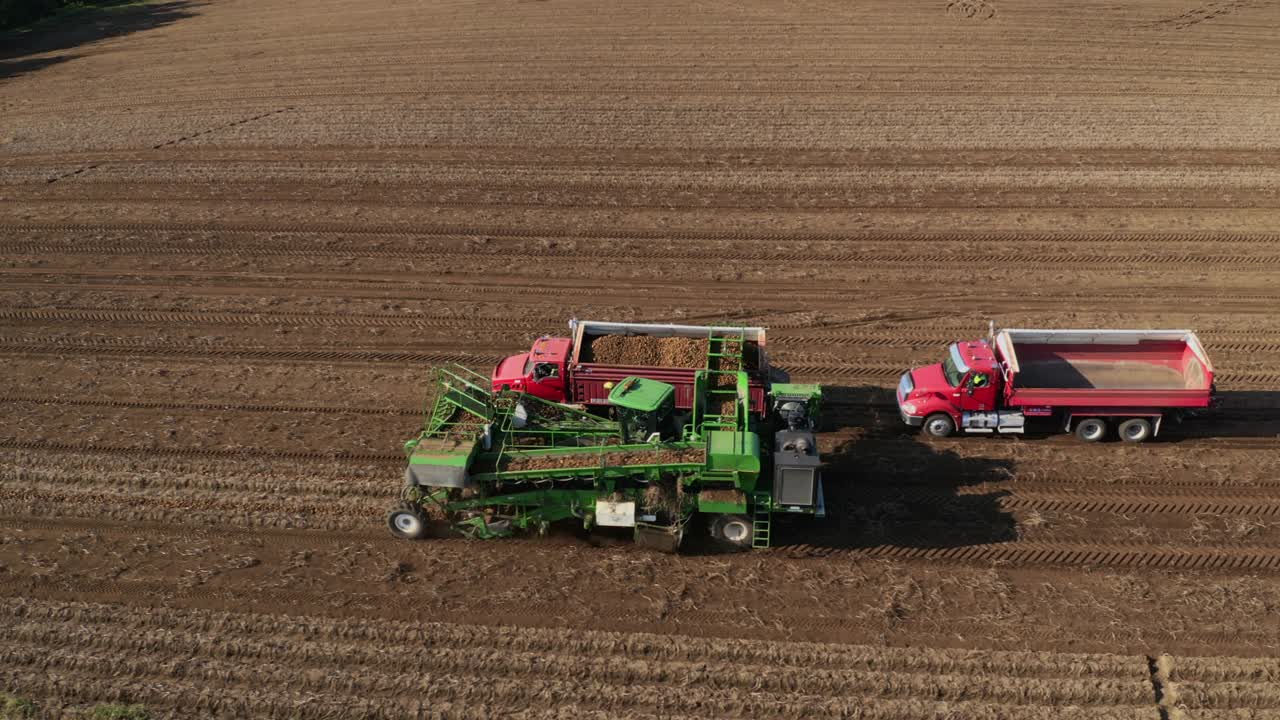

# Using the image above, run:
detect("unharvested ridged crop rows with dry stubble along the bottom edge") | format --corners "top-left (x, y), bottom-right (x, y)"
top-left (0, 600), bottom-right (1280, 717)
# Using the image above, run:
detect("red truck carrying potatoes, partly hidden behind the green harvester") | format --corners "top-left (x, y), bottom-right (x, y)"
top-left (493, 320), bottom-right (769, 414)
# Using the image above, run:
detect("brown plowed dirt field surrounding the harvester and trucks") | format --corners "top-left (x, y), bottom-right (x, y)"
top-left (0, 0), bottom-right (1280, 720)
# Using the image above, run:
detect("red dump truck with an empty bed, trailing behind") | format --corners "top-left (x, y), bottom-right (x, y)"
top-left (897, 329), bottom-right (1213, 442)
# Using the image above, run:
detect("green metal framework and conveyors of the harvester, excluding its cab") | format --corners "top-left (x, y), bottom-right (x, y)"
top-left (394, 348), bottom-right (820, 547)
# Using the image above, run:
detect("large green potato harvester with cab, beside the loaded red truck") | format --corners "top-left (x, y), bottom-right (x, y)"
top-left (387, 336), bottom-right (824, 552)
